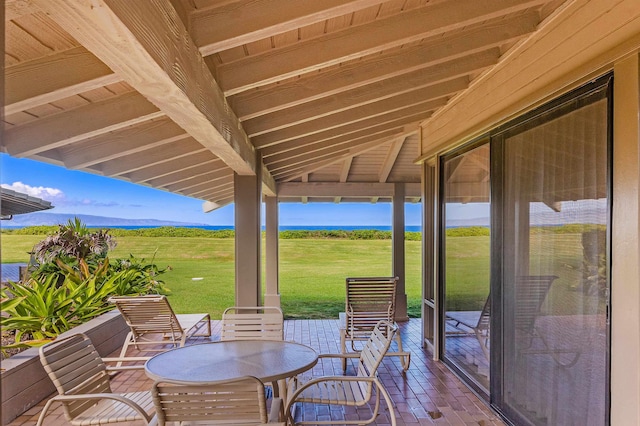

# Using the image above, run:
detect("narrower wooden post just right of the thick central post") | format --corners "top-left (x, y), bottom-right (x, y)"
top-left (264, 197), bottom-right (280, 307)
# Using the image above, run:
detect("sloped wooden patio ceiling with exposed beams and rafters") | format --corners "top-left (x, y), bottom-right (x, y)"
top-left (2, 0), bottom-right (564, 205)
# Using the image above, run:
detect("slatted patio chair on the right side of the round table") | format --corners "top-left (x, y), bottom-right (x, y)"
top-left (285, 320), bottom-right (398, 425)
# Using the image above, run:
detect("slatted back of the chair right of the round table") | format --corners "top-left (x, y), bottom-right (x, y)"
top-left (356, 320), bottom-right (398, 396)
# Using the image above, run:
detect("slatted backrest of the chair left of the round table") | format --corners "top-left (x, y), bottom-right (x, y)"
top-left (40, 333), bottom-right (111, 421)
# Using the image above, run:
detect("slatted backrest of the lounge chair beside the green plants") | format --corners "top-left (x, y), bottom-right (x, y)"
top-left (109, 295), bottom-right (183, 339)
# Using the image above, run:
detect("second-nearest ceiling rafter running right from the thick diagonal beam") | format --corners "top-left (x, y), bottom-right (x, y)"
top-left (217, 0), bottom-right (548, 96)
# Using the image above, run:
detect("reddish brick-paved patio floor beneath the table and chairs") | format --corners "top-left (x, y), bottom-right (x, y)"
top-left (7, 319), bottom-right (504, 426)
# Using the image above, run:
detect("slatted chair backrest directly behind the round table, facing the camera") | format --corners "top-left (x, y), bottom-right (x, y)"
top-left (220, 306), bottom-right (284, 340)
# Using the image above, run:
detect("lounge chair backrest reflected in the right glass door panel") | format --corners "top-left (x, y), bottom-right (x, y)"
top-left (515, 275), bottom-right (558, 334)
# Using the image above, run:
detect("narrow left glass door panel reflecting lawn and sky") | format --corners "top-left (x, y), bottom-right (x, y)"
top-left (442, 143), bottom-right (491, 393)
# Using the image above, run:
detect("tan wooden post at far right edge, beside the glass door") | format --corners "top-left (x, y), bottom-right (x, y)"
top-left (610, 53), bottom-right (640, 425)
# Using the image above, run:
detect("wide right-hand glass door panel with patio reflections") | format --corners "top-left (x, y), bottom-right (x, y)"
top-left (492, 81), bottom-right (609, 426)
